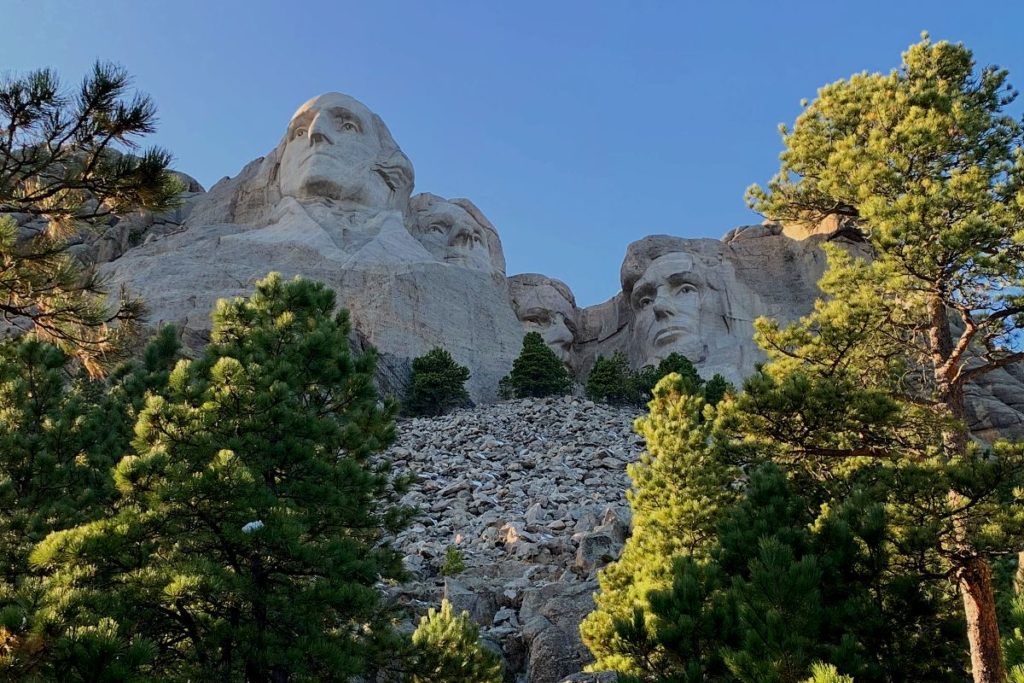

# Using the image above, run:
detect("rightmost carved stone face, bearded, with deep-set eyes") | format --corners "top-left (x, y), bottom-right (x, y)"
top-left (630, 252), bottom-right (707, 366)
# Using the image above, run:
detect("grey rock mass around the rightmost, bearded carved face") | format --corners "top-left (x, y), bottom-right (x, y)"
top-left (575, 225), bottom-right (864, 382)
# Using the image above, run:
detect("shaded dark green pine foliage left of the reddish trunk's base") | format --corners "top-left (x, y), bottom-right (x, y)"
top-left (615, 466), bottom-right (958, 683)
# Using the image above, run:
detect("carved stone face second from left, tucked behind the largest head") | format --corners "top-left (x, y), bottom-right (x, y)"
top-left (413, 202), bottom-right (494, 272)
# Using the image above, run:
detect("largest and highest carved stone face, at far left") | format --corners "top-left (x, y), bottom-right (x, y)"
top-left (278, 92), bottom-right (412, 208)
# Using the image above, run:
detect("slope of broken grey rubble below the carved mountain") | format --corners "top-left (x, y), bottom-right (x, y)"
top-left (387, 396), bottom-right (643, 683)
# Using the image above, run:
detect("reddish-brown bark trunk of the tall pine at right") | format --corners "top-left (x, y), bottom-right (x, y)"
top-left (929, 297), bottom-right (1007, 683)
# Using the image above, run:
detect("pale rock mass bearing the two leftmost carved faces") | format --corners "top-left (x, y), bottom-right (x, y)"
top-left (103, 93), bottom-right (522, 400)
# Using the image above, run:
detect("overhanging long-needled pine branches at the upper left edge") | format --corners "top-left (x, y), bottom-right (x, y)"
top-left (0, 62), bottom-right (179, 374)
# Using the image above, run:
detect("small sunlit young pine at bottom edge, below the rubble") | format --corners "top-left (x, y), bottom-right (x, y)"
top-left (412, 600), bottom-right (503, 683)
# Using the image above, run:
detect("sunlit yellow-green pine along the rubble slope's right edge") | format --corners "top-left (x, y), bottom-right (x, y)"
top-left (580, 374), bottom-right (739, 674)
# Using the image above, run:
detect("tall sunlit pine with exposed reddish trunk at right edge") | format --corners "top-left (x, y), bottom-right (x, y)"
top-left (749, 36), bottom-right (1024, 682)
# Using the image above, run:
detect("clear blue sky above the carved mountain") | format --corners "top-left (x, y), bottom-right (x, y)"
top-left (0, 0), bottom-right (1024, 305)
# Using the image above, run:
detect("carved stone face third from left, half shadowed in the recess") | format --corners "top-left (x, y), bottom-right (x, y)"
top-left (509, 274), bottom-right (577, 364)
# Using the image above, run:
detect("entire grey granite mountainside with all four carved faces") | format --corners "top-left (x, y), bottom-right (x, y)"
top-left (94, 92), bottom-right (1024, 434)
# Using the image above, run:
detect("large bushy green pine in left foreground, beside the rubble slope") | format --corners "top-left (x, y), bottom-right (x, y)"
top-left (32, 274), bottom-right (408, 681)
